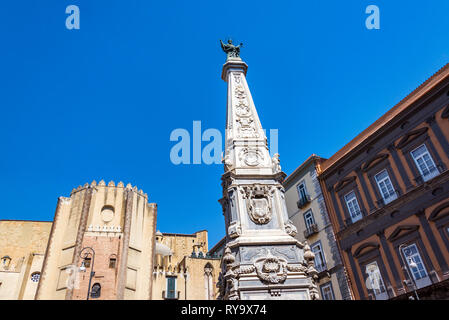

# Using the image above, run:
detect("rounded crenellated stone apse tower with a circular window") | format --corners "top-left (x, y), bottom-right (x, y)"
top-left (36, 181), bottom-right (157, 300)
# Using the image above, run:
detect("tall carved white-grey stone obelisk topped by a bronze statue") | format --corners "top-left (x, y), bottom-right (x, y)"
top-left (219, 40), bottom-right (318, 300)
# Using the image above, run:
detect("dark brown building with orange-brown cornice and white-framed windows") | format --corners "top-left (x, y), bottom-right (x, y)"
top-left (319, 65), bottom-right (449, 299)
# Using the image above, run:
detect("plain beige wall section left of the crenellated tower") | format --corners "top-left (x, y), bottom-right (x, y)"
top-left (0, 220), bottom-right (52, 300)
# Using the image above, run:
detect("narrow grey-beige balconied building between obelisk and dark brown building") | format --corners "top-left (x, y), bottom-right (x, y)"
top-left (283, 155), bottom-right (351, 300)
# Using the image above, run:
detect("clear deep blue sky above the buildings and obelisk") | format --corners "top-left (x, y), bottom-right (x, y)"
top-left (0, 0), bottom-right (449, 245)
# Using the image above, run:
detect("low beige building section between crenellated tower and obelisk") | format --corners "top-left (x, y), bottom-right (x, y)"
top-left (153, 230), bottom-right (224, 300)
